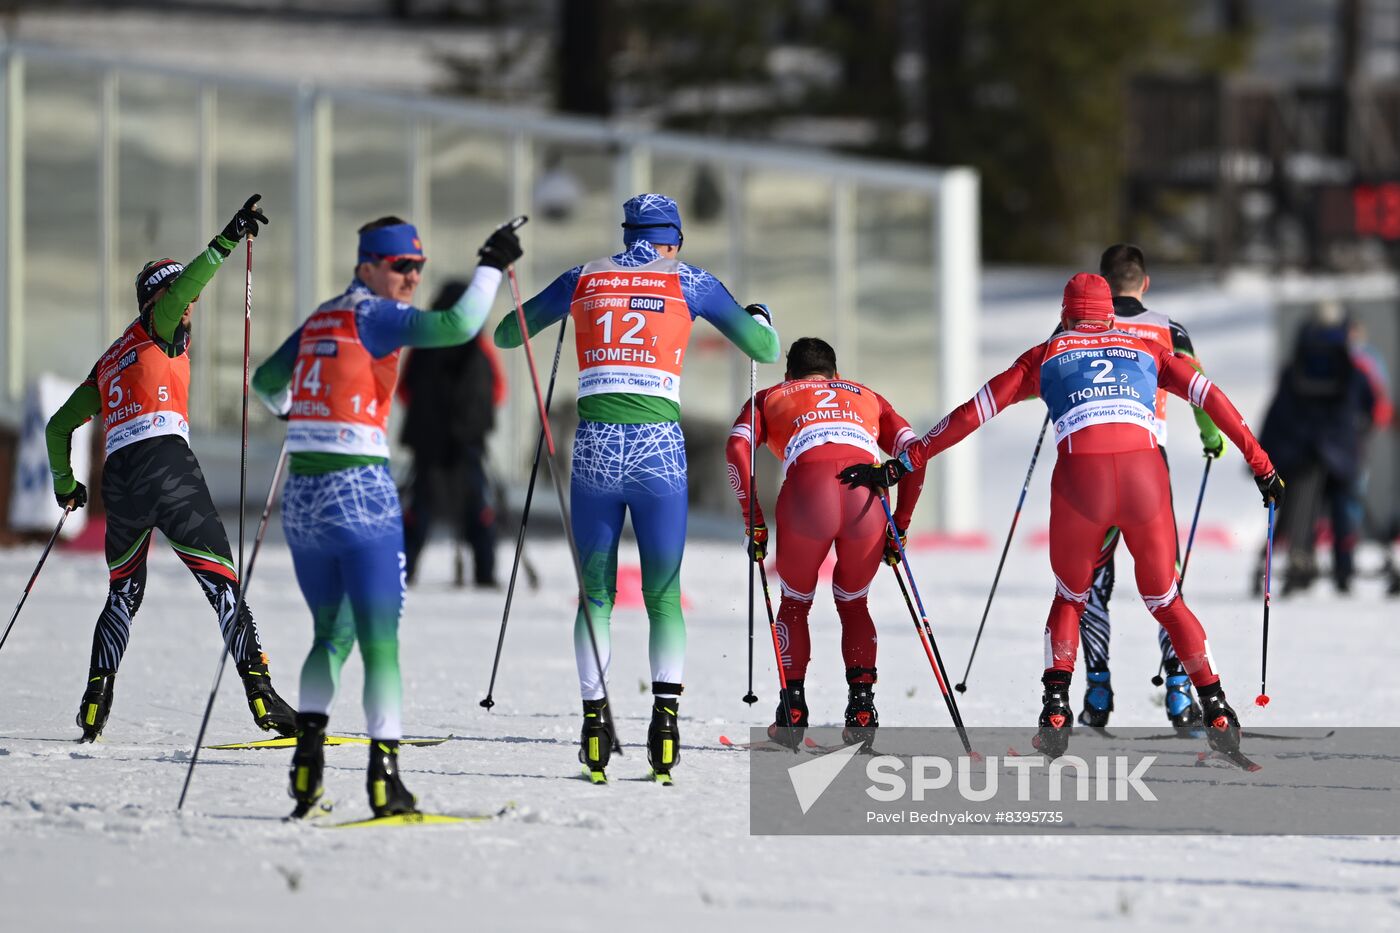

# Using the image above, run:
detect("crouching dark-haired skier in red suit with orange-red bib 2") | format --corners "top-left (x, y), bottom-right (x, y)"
top-left (725, 338), bottom-right (924, 748)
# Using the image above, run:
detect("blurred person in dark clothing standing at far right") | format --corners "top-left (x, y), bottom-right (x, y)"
top-left (1260, 303), bottom-right (1390, 595)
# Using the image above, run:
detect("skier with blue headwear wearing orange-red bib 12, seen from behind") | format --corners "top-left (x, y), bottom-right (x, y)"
top-left (496, 195), bottom-right (780, 780)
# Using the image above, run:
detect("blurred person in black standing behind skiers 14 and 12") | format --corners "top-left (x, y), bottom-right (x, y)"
top-left (398, 280), bottom-right (505, 587)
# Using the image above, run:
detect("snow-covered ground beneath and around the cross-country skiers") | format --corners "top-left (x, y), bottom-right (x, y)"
top-left (0, 276), bottom-right (1400, 932)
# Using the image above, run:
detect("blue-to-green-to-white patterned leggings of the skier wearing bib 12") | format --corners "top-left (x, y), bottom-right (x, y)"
top-left (571, 422), bottom-right (689, 699)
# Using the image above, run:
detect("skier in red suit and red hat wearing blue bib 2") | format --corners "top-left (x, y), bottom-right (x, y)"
top-left (841, 272), bottom-right (1284, 758)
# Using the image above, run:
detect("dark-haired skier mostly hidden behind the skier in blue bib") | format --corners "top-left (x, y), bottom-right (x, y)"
top-left (1079, 242), bottom-right (1225, 728)
